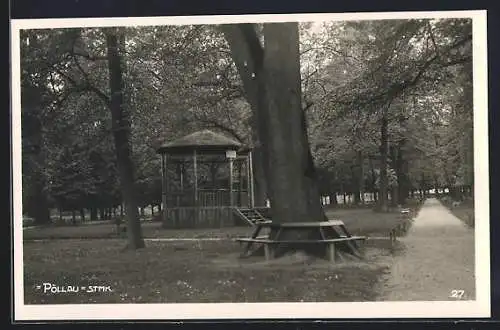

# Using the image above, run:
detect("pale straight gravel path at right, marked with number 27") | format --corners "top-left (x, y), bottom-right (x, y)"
top-left (380, 198), bottom-right (475, 301)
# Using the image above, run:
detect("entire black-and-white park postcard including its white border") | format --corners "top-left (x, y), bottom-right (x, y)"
top-left (11, 11), bottom-right (490, 320)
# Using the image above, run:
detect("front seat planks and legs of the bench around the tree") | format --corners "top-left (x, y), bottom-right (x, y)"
top-left (236, 236), bottom-right (366, 262)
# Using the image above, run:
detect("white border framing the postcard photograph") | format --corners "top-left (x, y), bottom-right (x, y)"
top-left (11, 10), bottom-right (490, 321)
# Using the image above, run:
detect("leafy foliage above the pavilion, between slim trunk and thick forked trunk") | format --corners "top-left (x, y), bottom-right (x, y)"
top-left (123, 25), bottom-right (261, 211)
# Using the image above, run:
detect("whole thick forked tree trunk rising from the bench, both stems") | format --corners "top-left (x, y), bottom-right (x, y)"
top-left (222, 23), bottom-right (326, 229)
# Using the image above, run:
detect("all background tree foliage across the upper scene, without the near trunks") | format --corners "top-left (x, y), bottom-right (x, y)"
top-left (21, 19), bottom-right (474, 219)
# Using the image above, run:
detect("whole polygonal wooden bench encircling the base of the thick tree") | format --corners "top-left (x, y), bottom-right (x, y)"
top-left (236, 220), bottom-right (366, 262)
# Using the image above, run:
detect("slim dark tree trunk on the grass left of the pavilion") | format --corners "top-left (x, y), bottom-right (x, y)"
top-left (106, 28), bottom-right (144, 249)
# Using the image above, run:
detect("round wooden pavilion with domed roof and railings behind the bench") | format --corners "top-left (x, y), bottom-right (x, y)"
top-left (157, 130), bottom-right (268, 228)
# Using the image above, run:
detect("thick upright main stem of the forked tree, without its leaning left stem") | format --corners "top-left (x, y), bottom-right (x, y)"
top-left (258, 23), bottom-right (325, 222)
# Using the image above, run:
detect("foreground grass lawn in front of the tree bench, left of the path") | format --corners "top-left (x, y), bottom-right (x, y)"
top-left (24, 239), bottom-right (398, 304)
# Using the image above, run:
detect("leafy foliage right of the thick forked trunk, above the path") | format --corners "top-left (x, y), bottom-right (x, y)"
top-left (303, 19), bottom-right (472, 201)
